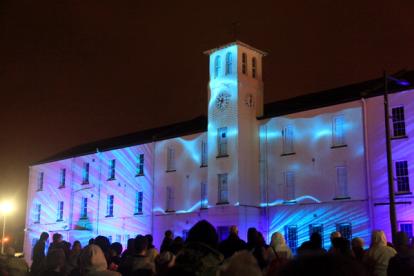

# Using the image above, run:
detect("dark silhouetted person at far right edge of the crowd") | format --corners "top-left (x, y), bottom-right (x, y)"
top-left (387, 232), bottom-right (414, 276)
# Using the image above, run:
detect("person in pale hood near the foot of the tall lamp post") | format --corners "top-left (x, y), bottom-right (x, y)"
top-left (364, 230), bottom-right (397, 276)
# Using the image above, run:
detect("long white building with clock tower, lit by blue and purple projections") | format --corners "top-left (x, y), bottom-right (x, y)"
top-left (25, 42), bottom-right (414, 259)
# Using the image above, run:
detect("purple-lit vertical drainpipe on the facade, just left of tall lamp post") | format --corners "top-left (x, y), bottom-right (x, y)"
top-left (361, 98), bottom-right (375, 230)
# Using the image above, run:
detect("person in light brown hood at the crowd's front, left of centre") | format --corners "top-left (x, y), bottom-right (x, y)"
top-left (79, 244), bottom-right (121, 276)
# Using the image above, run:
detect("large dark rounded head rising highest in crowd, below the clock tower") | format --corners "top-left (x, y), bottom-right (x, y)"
top-left (187, 220), bottom-right (218, 248)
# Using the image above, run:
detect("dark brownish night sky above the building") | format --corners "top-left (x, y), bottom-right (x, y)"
top-left (0, 0), bottom-right (414, 245)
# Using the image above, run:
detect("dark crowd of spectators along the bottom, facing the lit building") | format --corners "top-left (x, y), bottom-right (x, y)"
top-left (1, 220), bottom-right (414, 276)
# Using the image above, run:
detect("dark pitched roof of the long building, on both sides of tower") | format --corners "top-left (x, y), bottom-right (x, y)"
top-left (35, 71), bottom-right (414, 165)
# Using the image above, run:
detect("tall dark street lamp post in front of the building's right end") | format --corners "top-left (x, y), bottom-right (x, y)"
top-left (384, 71), bottom-right (410, 242)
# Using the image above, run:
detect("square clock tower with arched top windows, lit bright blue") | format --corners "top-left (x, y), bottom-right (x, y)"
top-left (205, 41), bottom-right (266, 207)
